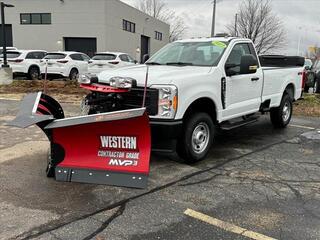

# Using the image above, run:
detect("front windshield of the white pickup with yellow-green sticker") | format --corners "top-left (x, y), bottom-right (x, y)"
top-left (146, 41), bottom-right (228, 66)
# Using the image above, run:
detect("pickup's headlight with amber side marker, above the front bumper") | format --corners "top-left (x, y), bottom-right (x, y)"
top-left (151, 85), bottom-right (178, 119)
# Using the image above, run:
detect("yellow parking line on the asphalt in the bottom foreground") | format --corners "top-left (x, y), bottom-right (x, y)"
top-left (184, 209), bottom-right (276, 240)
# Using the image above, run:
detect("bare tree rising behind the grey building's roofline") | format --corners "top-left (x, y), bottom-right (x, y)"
top-left (136, 0), bottom-right (187, 42)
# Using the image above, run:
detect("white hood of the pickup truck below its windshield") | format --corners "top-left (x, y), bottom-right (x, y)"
top-left (98, 65), bottom-right (212, 87)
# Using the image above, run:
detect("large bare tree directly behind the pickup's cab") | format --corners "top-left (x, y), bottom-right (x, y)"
top-left (227, 0), bottom-right (286, 54)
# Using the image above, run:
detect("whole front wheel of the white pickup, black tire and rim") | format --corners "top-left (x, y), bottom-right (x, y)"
top-left (177, 112), bottom-right (215, 163)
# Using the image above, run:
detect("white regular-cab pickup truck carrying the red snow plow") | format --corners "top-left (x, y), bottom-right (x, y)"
top-left (82, 37), bottom-right (303, 162)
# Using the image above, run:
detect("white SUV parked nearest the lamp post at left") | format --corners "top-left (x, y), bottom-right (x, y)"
top-left (0, 50), bottom-right (47, 80)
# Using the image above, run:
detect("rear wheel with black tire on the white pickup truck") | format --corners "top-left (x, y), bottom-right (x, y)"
top-left (270, 93), bottom-right (293, 128)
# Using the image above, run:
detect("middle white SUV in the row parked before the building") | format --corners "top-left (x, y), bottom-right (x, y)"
top-left (40, 52), bottom-right (90, 80)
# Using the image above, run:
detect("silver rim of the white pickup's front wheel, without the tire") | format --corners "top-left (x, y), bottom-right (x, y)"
top-left (192, 122), bottom-right (210, 154)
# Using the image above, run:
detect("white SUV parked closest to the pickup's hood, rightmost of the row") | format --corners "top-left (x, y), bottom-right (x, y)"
top-left (89, 52), bottom-right (137, 74)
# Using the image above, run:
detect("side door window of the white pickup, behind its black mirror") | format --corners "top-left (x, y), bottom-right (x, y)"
top-left (226, 43), bottom-right (251, 75)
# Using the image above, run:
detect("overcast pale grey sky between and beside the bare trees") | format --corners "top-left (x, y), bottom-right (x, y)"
top-left (122, 0), bottom-right (320, 55)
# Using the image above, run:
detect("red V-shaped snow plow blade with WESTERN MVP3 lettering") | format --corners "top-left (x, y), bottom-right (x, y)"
top-left (9, 92), bottom-right (151, 188)
